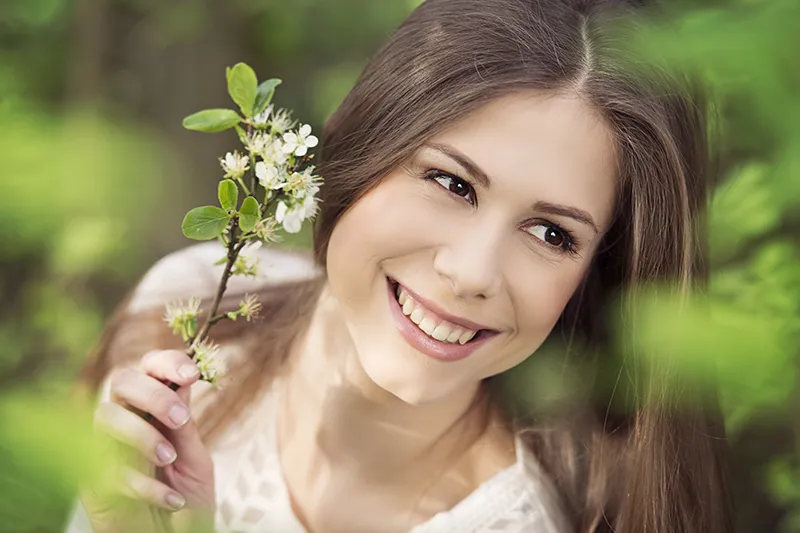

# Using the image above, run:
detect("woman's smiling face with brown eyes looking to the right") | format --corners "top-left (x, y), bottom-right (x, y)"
top-left (327, 93), bottom-right (616, 404)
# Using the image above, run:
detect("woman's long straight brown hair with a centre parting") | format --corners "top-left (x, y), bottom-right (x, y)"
top-left (85, 0), bottom-right (732, 533)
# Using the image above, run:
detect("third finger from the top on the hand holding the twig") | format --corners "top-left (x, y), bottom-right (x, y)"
top-left (94, 402), bottom-right (177, 466)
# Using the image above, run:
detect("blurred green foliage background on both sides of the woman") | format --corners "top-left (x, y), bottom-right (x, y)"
top-left (0, 0), bottom-right (800, 533)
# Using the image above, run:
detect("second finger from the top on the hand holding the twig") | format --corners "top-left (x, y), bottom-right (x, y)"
top-left (111, 368), bottom-right (191, 429)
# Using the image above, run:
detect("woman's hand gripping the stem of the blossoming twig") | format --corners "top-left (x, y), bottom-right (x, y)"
top-left (81, 350), bottom-right (215, 533)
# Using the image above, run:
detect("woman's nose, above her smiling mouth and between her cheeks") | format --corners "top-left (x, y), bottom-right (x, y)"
top-left (433, 223), bottom-right (502, 300)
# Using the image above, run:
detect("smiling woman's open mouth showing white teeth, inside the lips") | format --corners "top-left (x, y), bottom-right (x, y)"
top-left (386, 277), bottom-right (499, 347)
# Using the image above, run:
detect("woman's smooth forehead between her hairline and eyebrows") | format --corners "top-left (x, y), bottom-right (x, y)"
top-left (432, 92), bottom-right (616, 226)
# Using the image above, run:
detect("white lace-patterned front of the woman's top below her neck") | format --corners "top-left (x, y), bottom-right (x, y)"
top-left (213, 376), bottom-right (566, 533)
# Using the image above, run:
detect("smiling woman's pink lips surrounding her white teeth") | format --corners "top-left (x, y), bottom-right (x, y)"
top-left (386, 278), bottom-right (497, 362)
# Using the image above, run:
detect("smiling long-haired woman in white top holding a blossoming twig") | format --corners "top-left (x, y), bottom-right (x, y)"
top-left (67, 0), bottom-right (731, 533)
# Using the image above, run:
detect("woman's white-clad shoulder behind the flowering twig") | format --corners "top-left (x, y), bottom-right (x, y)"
top-left (127, 241), bottom-right (319, 313)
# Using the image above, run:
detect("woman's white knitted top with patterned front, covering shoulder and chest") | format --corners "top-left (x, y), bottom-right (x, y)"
top-left (66, 242), bottom-right (569, 533)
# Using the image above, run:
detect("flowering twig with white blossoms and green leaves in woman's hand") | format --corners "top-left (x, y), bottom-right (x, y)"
top-left (164, 63), bottom-right (322, 382)
